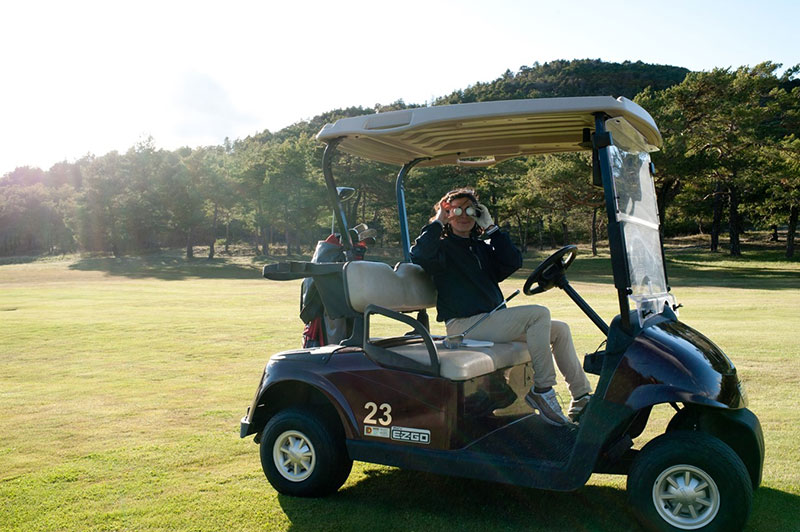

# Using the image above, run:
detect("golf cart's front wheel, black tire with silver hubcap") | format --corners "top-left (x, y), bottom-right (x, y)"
top-left (628, 431), bottom-right (753, 532)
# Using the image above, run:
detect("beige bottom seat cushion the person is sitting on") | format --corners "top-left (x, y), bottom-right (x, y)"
top-left (390, 342), bottom-right (531, 381)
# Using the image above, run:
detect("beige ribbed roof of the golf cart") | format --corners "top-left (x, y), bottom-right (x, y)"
top-left (317, 96), bottom-right (661, 166)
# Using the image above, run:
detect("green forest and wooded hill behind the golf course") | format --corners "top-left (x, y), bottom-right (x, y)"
top-left (0, 59), bottom-right (800, 258)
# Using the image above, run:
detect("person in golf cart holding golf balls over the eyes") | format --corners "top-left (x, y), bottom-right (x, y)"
top-left (411, 188), bottom-right (591, 425)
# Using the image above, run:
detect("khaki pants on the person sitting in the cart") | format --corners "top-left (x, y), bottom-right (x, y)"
top-left (447, 305), bottom-right (592, 398)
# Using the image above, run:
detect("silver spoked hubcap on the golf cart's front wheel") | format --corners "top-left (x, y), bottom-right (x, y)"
top-left (653, 464), bottom-right (720, 530)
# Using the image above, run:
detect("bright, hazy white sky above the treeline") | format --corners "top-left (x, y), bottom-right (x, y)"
top-left (0, 0), bottom-right (800, 175)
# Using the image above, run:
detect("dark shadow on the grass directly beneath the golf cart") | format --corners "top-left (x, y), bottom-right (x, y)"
top-left (278, 469), bottom-right (800, 532)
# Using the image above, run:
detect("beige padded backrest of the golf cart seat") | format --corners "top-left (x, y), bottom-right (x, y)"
top-left (344, 260), bottom-right (436, 313)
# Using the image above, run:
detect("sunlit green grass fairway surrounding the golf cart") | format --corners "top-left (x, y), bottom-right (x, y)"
top-left (0, 244), bottom-right (800, 532)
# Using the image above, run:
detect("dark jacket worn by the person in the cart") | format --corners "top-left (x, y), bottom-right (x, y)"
top-left (411, 222), bottom-right (522, 321)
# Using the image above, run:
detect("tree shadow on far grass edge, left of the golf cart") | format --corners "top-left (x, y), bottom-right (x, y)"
top-left (69, 254), bottom-right (262, 281)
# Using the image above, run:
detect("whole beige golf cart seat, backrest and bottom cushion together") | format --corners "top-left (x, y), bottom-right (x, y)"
top-left (344, 261), bottom-right (530, 381)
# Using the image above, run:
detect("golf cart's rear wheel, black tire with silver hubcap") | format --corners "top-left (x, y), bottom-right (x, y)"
top-left (260, 408), bottom-right (353, 497)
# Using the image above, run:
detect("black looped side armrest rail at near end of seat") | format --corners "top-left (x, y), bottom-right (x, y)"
top-left (363, 305), bottom-right (440, 377)
